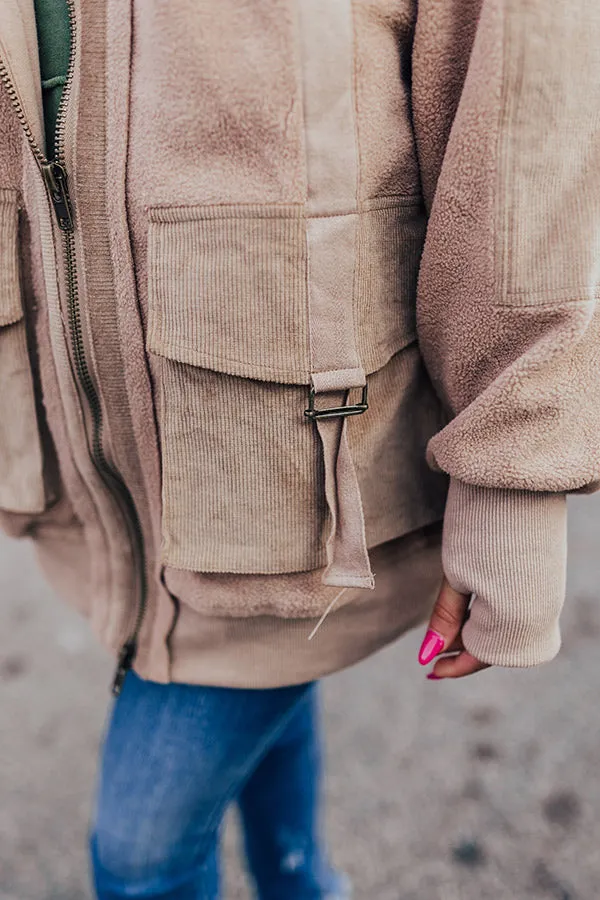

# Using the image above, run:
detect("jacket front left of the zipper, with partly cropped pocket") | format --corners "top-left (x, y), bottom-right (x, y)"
top-left (0, 47), bottom-right (129, 648)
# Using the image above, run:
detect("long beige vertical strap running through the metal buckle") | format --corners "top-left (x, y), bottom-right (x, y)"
top-left (297, 0), bottom-right (374, 588)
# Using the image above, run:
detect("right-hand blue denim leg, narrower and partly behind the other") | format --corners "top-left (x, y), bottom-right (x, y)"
top-left (239, 686), bottom-right (349, 900)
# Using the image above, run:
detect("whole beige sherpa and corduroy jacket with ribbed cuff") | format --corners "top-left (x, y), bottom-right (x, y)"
top-left (0, 0), bottom-right (600, 687)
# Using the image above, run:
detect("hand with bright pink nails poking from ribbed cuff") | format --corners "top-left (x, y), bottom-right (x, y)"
top-left (419, 578), bottom-right (489, 681)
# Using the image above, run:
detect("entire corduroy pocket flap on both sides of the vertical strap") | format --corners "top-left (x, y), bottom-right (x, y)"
top-left (147, 198), bottom-right (426, 384)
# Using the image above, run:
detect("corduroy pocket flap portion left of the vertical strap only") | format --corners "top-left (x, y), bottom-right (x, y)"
top-left (147, 204), bottom-right (310, 384)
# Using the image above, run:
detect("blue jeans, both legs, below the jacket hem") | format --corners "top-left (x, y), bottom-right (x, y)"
top-left (91, 672), bottom-right (349, 900)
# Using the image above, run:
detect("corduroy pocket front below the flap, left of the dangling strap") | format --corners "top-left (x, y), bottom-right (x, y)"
top-left (159, 368), bottom-right (324, 573)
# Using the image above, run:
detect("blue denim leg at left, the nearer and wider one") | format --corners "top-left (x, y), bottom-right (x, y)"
top-left (91, 673), bottom-right (310, 900)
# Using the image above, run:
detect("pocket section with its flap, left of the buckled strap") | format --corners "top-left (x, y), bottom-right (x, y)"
top-left (147, 206), bottom-right (325, 574)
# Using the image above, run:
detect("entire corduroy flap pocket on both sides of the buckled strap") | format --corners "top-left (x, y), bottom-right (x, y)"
top-left (147, 199), bottom-right (439, 574)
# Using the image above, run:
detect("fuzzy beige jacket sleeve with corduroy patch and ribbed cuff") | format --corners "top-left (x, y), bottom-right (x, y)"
top-left (412, 0), bottom-right (600, 666)
